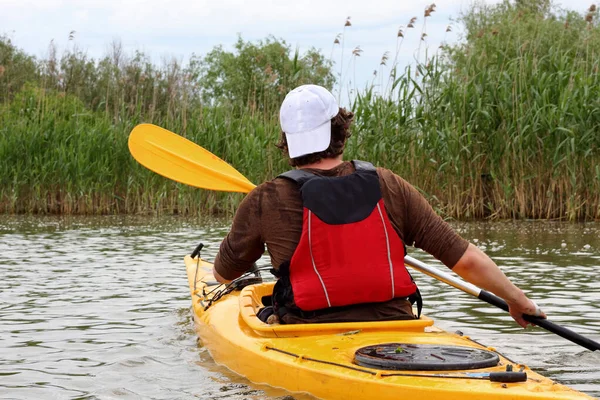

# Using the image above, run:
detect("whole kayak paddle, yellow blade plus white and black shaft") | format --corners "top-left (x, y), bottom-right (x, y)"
top-left (129, 124), bottom-right (600, 351)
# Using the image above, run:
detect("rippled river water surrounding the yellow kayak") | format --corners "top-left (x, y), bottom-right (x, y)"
top-left (0, 216), bottom-right (600, 399)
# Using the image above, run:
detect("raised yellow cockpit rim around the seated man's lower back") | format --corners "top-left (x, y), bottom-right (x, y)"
top-left (239, 282), bottom-right (433, 337)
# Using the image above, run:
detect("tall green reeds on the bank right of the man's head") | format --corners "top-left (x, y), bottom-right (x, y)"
top-left (353, 2), bottom-right (600, 220)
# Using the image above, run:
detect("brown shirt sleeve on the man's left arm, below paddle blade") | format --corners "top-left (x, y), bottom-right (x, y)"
top-left (214, 186), bottom-right (265, 280)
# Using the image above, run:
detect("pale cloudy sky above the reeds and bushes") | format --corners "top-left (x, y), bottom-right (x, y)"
top-left (0, 0), bottom-right (593, 100)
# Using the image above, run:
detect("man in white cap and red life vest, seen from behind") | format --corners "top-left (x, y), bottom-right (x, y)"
top-left (213, 85), bottom-right (545, 327)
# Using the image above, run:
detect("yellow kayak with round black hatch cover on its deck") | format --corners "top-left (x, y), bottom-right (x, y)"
top-left (185, 256), bottom-right (592, 400)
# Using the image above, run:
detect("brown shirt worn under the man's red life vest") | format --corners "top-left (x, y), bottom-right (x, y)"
top-left (214, 162), bottom-right (468, 279)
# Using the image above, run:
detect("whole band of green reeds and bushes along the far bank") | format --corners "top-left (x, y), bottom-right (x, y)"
top-left (0, 0), bottom-right (600, 221)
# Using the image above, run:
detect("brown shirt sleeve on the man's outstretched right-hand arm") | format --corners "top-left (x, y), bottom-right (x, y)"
top-left (378, 168), bottom-right (469, 268)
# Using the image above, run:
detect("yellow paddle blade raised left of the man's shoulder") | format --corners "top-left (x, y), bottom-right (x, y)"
top-left (129, 124), bottom-right (255, 193)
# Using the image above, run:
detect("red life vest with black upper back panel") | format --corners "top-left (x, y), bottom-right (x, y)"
top-left (280, 161), bottom-right (417, 311)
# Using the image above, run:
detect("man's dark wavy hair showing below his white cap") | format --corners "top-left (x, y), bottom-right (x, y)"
top-left (276, 107), bottom-right (354, 167)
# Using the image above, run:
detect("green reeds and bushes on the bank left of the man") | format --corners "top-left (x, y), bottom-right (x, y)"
top-left (0, 35), bottom-right (314, 214)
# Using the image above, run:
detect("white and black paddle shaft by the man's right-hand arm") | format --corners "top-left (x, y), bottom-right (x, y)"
top-left (404, 256), bottom-right (600, 351)
